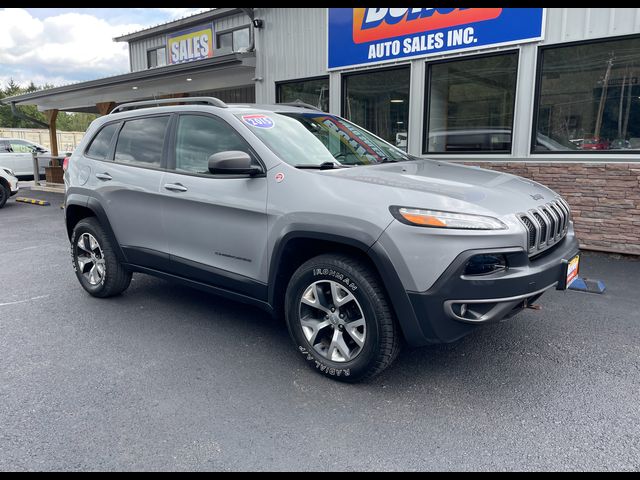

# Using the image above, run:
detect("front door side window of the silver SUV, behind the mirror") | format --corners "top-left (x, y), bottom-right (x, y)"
top-left (176, 115), bottom-right (253, 174)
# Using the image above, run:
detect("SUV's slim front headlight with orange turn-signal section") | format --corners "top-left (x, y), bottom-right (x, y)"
top-left (389, 207), bottom-right (507, 230)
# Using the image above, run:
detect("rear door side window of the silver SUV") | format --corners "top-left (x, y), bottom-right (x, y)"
top-left (114, 116), bottom-right (169, 167)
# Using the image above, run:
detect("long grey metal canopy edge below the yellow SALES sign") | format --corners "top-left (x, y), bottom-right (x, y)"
top-left (0, 52), bottom-right (255, 113)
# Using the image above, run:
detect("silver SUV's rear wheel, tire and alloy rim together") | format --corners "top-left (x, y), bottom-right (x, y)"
top-left (71, 218), bottom-right (131, 298)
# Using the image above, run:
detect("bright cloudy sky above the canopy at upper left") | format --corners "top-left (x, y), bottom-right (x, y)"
top-left (0, 8), bottom-right (207, 88)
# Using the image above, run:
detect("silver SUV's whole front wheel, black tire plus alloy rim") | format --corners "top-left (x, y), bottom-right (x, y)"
top-left (285, 254), bottom-right (399, 382)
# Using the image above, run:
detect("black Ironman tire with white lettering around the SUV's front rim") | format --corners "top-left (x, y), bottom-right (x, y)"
top-left (285, 254), bottom-right (400, 383)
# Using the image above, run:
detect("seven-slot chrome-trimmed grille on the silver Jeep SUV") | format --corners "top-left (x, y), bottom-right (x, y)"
top-left (518, 198), bottom-right (571, 256)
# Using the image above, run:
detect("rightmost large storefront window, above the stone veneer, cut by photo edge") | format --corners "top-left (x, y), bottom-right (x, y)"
top-left (533, 38), bottom-right (640, 153)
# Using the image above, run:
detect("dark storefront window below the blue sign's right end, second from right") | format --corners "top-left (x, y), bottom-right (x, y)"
top-left (424, 53), bottom-right (518, 153)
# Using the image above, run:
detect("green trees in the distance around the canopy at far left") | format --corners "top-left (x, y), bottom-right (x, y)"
top-left (0, 79), bottom-right (97, 132)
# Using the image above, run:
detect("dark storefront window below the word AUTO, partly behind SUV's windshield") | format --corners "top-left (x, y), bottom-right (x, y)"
top-left (342, 66), bottom-right (410, 151)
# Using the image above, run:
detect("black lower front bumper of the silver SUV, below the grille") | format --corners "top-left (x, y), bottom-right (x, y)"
top-left (407, 234), bottom-right (579, 345)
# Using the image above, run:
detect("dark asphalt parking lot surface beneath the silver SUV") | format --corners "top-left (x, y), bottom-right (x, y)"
top-left (0, 190), bottom-right (640, 470)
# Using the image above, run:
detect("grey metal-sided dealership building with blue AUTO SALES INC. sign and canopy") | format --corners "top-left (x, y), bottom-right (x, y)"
top-left (4, 8), bottom-right (640, 254)
